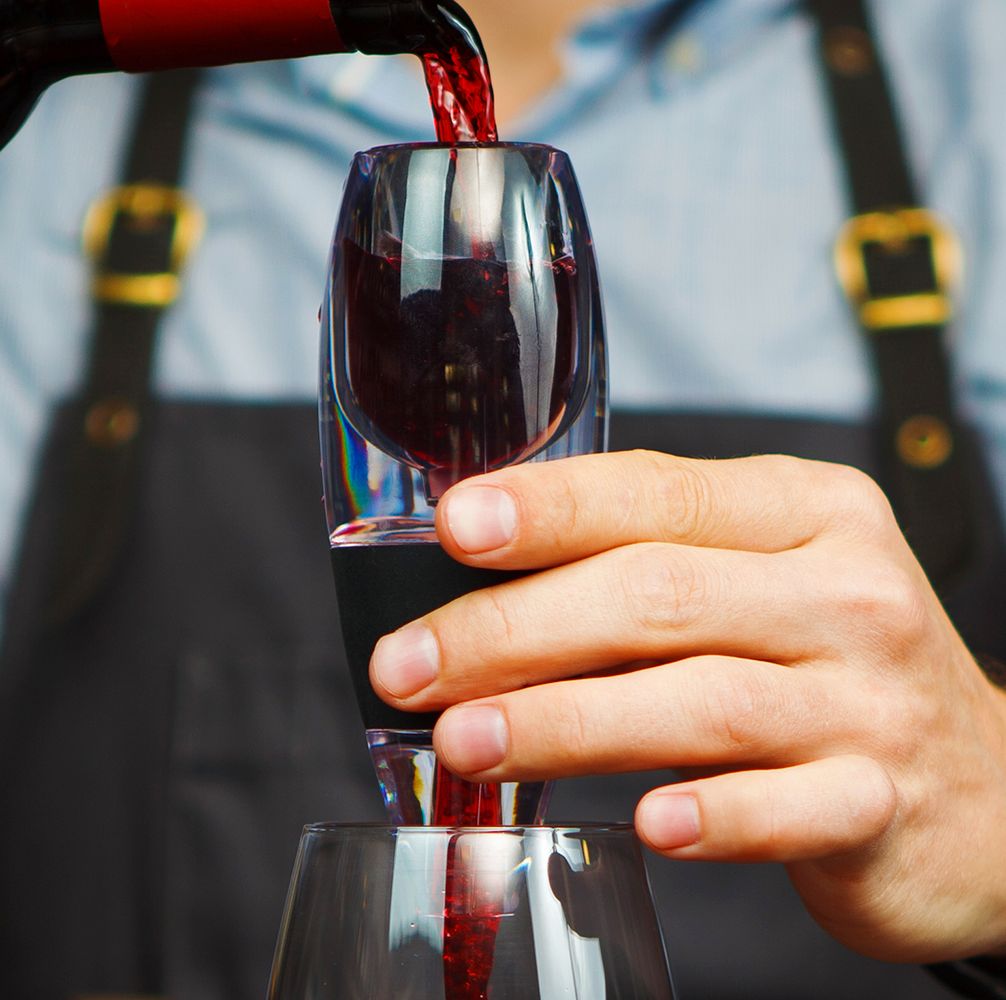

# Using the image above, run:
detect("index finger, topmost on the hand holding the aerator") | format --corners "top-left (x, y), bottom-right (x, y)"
top-left (437, 452), bottom-right (893, 568)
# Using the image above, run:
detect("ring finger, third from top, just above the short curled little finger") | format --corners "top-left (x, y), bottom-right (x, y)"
top-left (434, 657), bottom-right (841, 782)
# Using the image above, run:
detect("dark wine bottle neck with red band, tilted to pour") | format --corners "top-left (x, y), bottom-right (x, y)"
top-left (0, 0), bottom-right (486, 149)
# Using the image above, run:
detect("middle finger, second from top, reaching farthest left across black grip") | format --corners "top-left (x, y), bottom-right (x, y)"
top-left (371, 543), bottom-right (866, 710)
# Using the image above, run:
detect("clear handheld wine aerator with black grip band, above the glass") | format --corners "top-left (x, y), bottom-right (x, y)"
top-left (320, 143), bottom-right (607, 825)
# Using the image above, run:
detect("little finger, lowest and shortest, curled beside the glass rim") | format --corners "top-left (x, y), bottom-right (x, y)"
top-left (636, 756), bottom-right (897, 862)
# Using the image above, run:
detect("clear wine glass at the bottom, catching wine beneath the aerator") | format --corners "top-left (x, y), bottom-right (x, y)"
top-left (269, 825), bottom-right (674, 1000)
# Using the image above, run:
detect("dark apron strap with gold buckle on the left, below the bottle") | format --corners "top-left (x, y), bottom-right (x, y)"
top-left (43, 69), bottom-right (202, 627)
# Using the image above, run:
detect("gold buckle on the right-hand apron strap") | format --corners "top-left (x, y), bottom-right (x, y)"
top-left (835, 208), bottom-right (962, 333)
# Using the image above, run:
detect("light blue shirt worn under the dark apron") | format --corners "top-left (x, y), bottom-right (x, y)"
top-left (0, 0), bottom-right (1006, 631)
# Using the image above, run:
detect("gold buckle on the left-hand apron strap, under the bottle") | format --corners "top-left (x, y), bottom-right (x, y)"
top-left (82, 184), bottom-right (205, 309)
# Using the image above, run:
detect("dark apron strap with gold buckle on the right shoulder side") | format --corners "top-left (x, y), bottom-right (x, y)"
top-left (808, 0), bottom-right (981, 585)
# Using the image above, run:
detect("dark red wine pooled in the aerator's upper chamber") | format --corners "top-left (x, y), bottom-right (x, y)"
top-left (343, 241), bottom-right (577, 501)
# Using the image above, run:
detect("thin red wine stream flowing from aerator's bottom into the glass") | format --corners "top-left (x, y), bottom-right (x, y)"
top-left (434, 764), bottom-right (503, 1000)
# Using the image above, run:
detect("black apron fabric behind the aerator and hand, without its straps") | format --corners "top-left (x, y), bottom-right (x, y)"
top-left (0, 7), bottom-right (1006, 1000)
